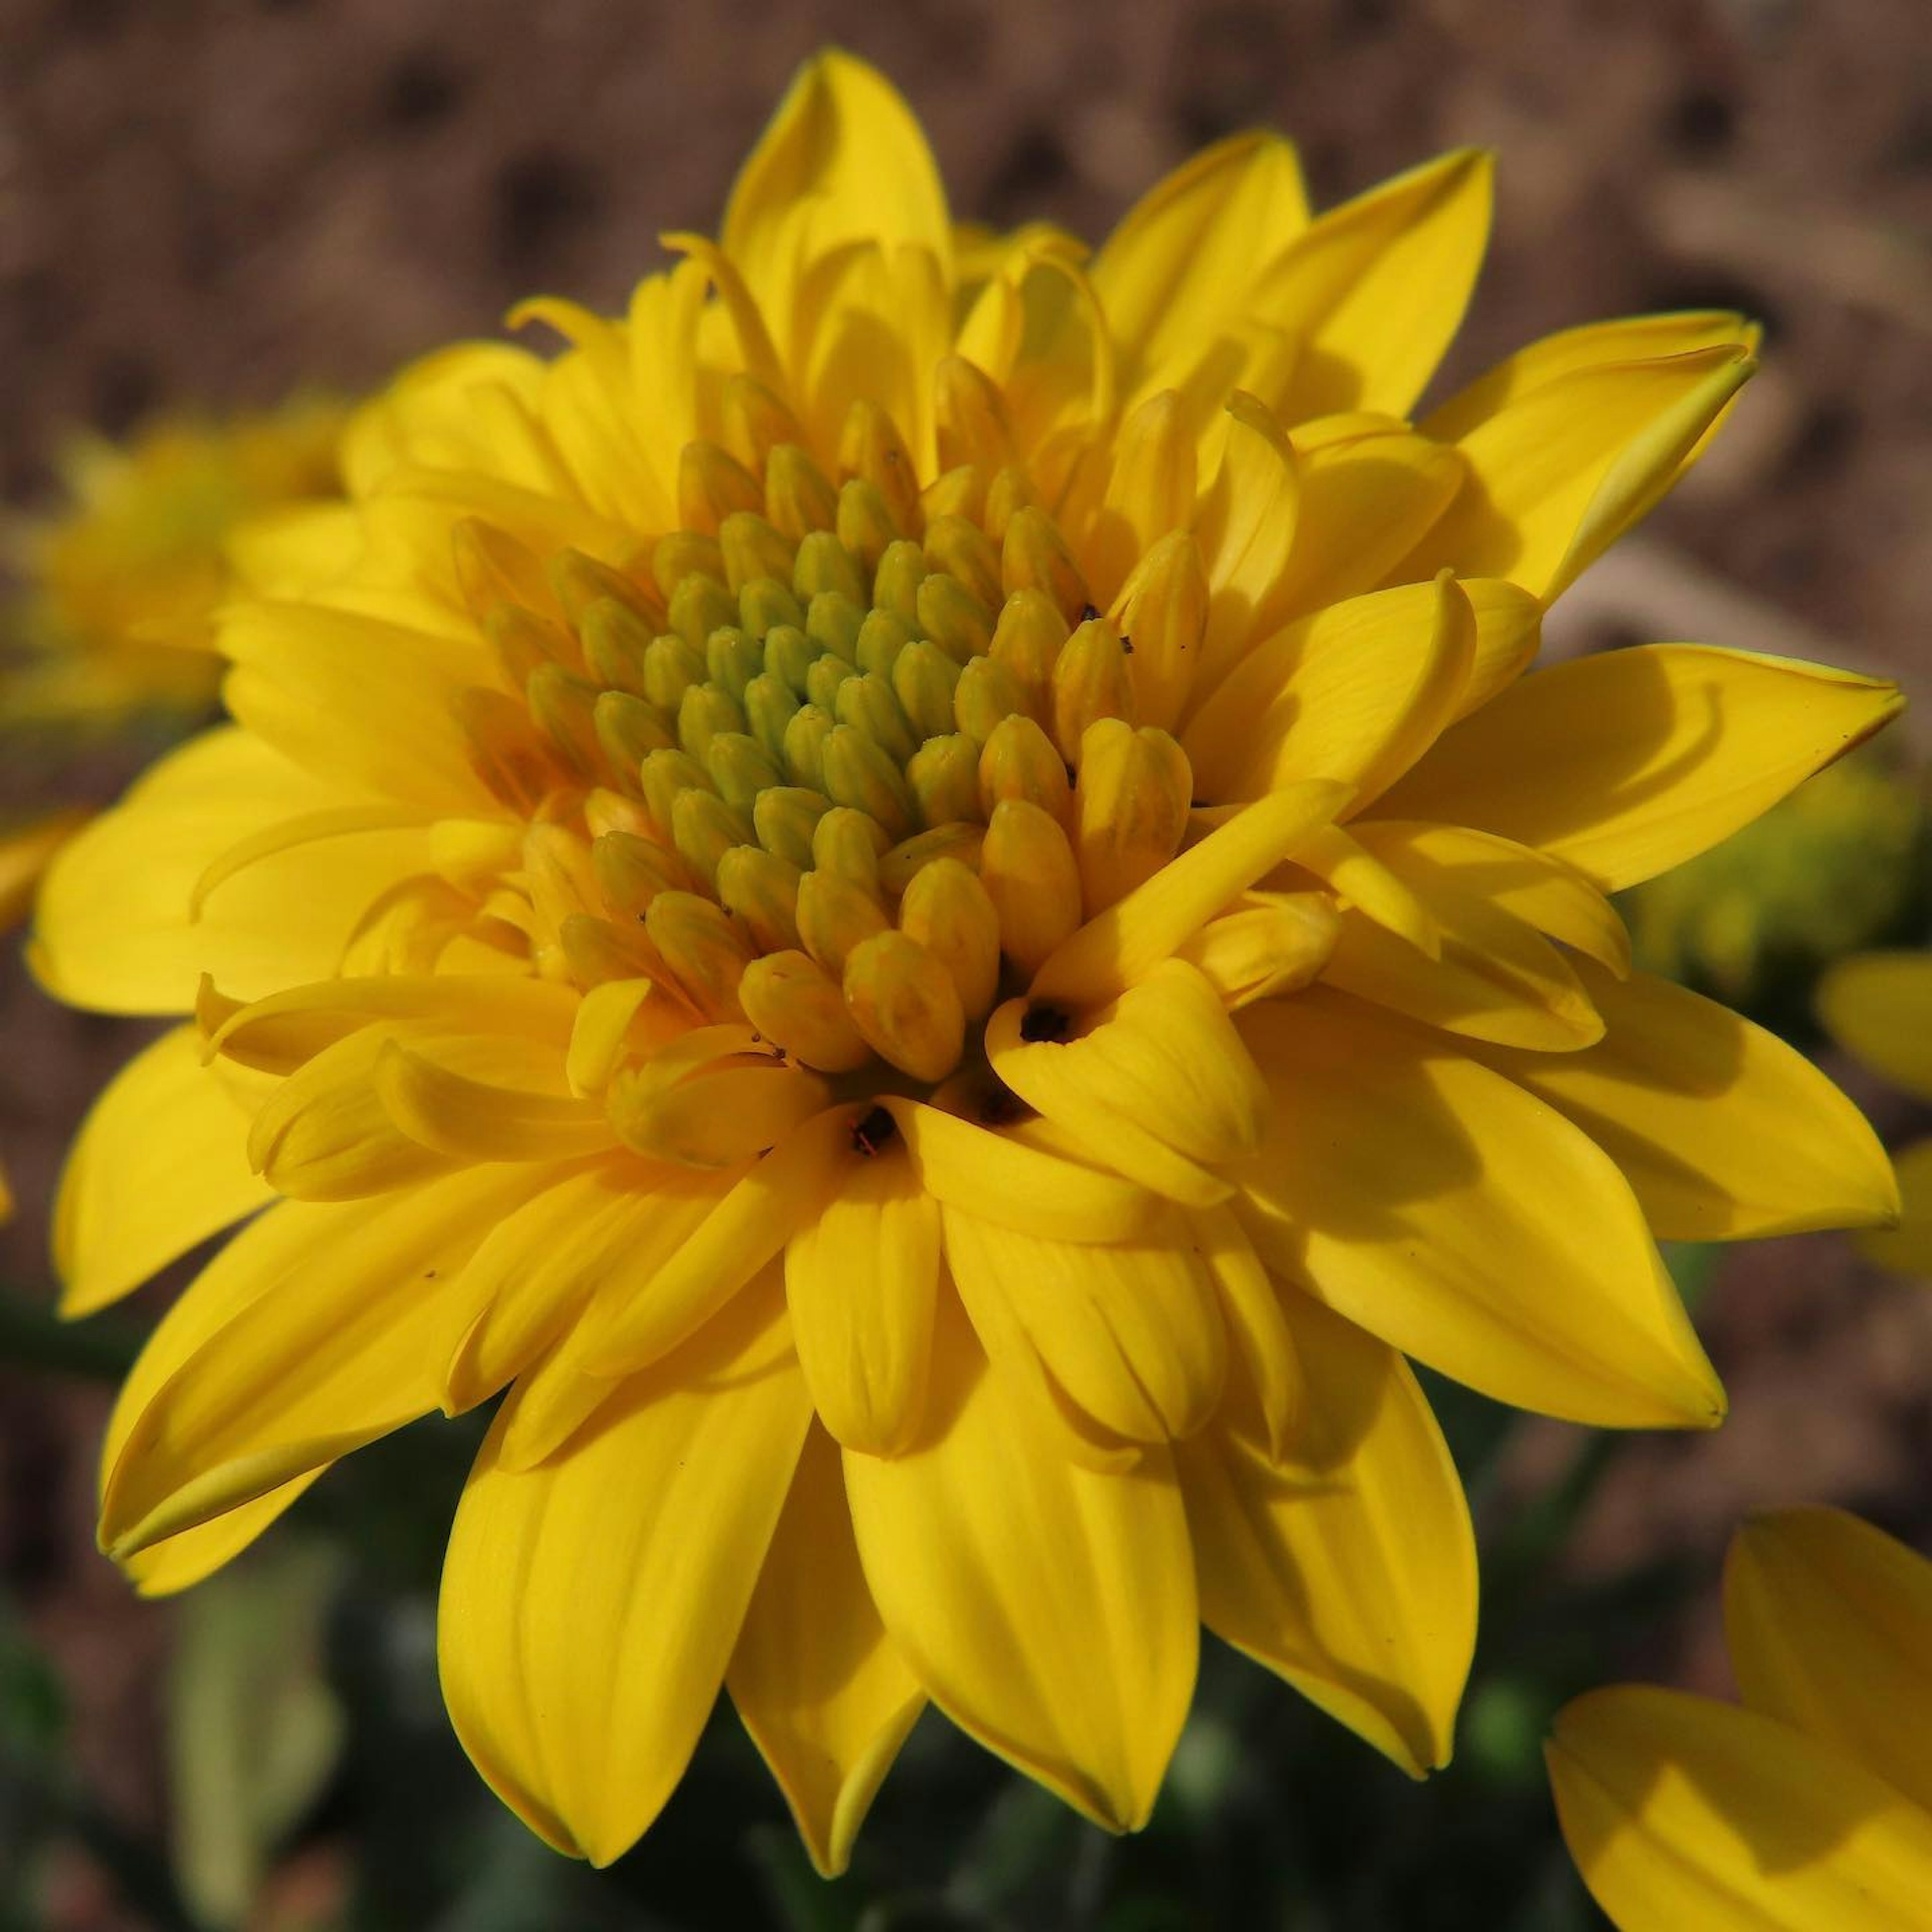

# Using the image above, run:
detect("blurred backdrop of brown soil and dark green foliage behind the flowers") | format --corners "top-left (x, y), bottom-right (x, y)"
top-left (0, 0), bottom-right (1932, 1932)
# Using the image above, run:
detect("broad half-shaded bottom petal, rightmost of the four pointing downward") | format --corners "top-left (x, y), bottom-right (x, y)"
top-left (1175, 1293), bottom-right (1476, 1778)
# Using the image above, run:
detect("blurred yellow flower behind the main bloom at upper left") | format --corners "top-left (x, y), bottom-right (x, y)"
top-left (0, 396), bottom-right (344, 731)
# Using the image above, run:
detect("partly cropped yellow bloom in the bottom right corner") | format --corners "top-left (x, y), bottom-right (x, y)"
top-left (1548, 1509), bottom-right (1932, 1932)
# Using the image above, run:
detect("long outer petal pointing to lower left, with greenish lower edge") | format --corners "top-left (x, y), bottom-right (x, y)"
top-left (101, 1169), bottom-right (547, 1557)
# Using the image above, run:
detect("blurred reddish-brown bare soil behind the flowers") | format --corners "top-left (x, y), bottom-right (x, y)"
top-left (0, 0), bottom-right (1932, 1926)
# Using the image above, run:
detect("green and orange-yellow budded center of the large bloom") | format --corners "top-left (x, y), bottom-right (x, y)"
top-left (458, 412), bottom-right (1190, 1128)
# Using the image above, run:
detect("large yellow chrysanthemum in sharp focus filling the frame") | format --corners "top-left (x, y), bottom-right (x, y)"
top-left (37, 58), bottom-right (1897, 1870)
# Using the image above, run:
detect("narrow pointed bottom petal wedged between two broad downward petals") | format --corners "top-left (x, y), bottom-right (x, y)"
top-left (725, 1430), bottom-right (925, 1878)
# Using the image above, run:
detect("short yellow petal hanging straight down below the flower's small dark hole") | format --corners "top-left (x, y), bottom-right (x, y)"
top-left (784, 1146), bottom-right (939, 1455)
